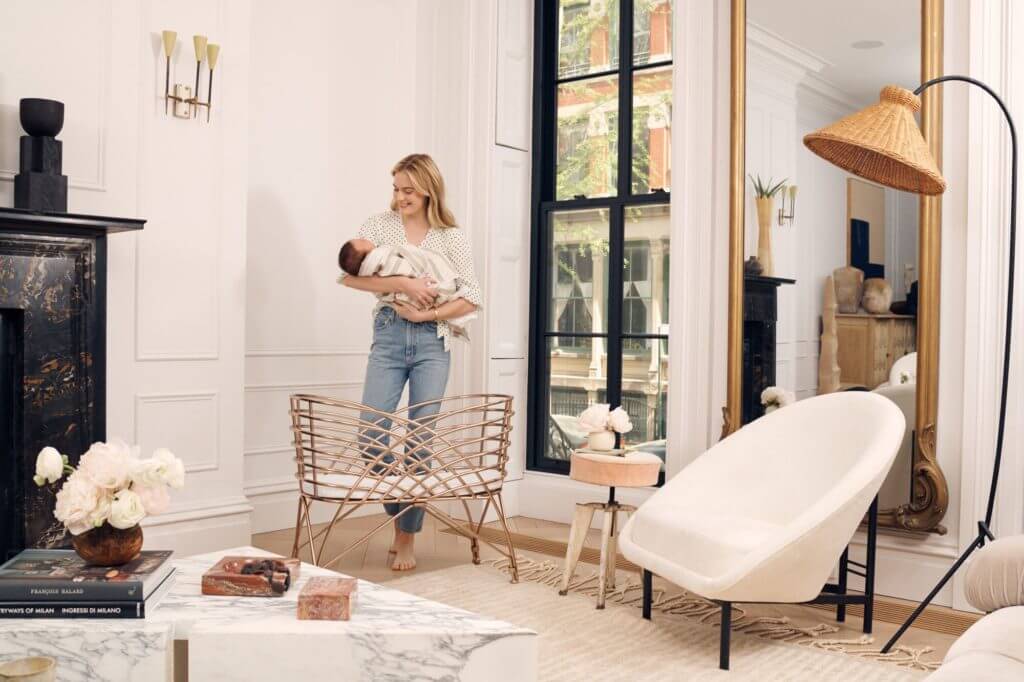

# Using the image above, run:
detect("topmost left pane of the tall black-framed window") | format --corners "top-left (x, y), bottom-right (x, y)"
top-left (558, 0), bottom-right (620, 79)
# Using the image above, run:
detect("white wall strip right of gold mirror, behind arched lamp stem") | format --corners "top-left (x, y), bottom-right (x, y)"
top-left (954, 0), bottom-right (1024, 605)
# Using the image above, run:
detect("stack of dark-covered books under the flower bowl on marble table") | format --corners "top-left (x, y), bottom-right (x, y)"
top-left (0, 549), bottom-right (174, 619)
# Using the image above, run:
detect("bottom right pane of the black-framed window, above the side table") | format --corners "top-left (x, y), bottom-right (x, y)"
top-left (623, 339), bottom-right (669, 461)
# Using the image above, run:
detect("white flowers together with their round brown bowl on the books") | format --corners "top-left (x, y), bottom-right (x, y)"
top-left (33, 440), bottom-right (185, 566)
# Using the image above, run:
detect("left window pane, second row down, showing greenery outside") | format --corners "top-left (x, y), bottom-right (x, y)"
top-left (555, 77), bottom-right (618, 199)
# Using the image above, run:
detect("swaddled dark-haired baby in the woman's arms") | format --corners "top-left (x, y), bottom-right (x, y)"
top-left (338, 240), bottom-right (476, 338)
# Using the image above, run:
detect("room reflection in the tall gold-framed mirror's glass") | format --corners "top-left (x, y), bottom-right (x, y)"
top-left (742, 0), bottom-right (921, 509)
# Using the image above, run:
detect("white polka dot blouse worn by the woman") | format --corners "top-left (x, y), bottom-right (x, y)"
top-left (358, 211), bottom-right (483, 349)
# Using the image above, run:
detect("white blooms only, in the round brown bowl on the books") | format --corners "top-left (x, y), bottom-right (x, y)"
top-left (33, 440), bottom-right (185, 536)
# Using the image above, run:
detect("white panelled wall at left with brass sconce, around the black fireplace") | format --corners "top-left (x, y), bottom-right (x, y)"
top-left (0, 0), bottom-right (250, 553)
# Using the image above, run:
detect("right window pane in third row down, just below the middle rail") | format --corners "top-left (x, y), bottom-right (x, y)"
top-left (623, 204), bottom-right (671, 331)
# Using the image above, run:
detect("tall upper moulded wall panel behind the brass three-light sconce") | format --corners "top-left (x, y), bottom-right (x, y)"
top-left (134, 0), bottom-right (228, 363)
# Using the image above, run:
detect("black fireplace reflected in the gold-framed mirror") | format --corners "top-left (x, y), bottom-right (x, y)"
top-left (742, 274), bottom-right (797, 424)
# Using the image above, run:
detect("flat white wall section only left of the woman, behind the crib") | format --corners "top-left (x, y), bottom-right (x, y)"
top-left (245, 0), bottom-right (417, 531)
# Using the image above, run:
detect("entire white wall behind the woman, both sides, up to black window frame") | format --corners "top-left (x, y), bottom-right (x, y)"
top-left (245, 0), bottom-right (531, 531)
